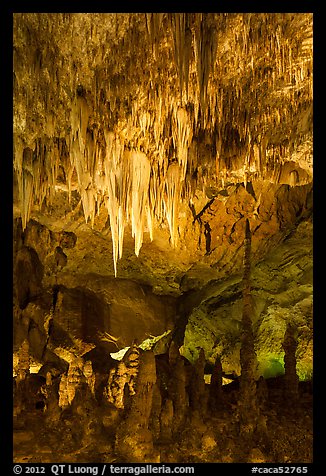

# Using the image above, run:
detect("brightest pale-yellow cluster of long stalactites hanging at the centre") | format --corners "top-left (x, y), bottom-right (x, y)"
top-left (69, 98), bottom-right (192, 275)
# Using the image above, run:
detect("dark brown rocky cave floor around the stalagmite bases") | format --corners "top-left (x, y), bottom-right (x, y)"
top-left (13, 388), bottom-right (313, 463)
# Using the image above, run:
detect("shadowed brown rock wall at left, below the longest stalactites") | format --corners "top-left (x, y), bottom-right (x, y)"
top-left (14, 219), bottom-right (176, 376)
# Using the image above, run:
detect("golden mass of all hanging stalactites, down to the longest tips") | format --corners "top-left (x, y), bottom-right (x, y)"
top-left (14, 13), bottom-right (312, 274)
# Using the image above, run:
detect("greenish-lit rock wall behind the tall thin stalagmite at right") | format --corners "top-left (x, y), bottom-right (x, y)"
top-left (182, 220), bottom-right (313, 379)
